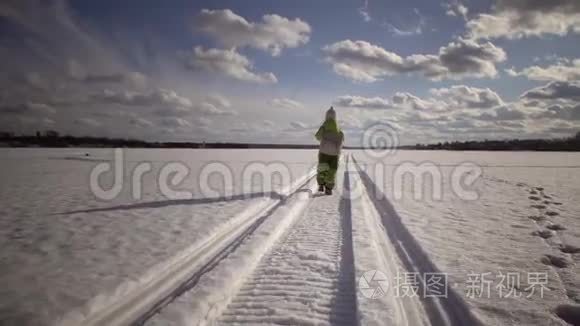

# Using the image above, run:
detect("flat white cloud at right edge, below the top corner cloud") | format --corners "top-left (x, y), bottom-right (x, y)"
top-left (506, 59), bottom-right (580, 81)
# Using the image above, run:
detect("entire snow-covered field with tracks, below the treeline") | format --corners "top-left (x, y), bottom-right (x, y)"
top-left (0, 149), bottom-right (580, 325)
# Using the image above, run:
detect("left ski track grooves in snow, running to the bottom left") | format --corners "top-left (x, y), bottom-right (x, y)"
top-left (65, 170), bottom-right (314, 326)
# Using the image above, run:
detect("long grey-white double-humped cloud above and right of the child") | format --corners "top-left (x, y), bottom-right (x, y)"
top-left (323, 39), bottom-right (506, 82)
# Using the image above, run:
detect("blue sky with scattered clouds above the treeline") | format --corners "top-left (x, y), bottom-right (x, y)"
top-left (0, 0), bottom-right (580, 145)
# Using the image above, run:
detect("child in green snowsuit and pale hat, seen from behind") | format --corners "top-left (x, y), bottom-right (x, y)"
top-left (315, 107), bottom-right (344, 195)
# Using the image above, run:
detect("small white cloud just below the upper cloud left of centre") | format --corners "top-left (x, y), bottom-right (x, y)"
top-left (183, 46), bottom-right (278, 84)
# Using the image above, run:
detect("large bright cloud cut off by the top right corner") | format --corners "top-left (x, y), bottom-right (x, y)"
top-left (467, 0), bottom-right (580, 39)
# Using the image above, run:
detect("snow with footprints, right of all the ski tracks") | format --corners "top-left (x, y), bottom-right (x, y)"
top-left (355, 151), bottom-right (580, 325)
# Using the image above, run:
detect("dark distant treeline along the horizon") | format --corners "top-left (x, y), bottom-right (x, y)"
top-left (0, 131), bottom-right (580, 151)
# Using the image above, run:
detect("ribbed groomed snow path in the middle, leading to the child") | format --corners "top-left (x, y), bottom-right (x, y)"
top-left (217, 167), bottom-right (358, 325)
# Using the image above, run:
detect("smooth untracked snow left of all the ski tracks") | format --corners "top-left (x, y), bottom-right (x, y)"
top-left (0, 149), bottom-right (314, 325)
